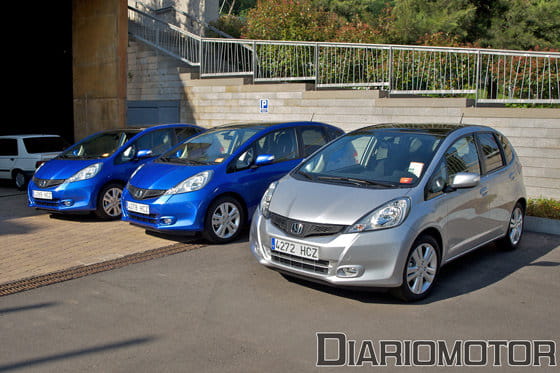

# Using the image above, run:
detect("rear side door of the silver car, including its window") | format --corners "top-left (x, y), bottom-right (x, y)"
top-left (476, 132), bottom-right (510, 240)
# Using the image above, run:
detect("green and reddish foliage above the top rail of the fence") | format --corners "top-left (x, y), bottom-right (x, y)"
top-left (230, 0), bottom-right (560, 49)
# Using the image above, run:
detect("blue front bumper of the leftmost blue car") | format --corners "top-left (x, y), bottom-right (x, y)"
top-left (27, 179), bottom-right (97, 213)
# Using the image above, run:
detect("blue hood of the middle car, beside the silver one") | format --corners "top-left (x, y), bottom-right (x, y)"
top-left (129, 162), bottom-right (217, 190)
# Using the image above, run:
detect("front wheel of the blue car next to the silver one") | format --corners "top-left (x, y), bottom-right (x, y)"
top-left (203, 196), bottom-right (245, 243)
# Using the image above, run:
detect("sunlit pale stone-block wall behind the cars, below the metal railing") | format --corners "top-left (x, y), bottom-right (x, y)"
top-left (181, 73), bottom-right (560, 199)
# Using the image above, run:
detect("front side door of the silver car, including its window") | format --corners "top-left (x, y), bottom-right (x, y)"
top-left (430, 134), bottom-right (489, 259)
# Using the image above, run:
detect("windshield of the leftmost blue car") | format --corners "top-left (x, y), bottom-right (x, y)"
top-left (59, 130), bottom-right (140, 159)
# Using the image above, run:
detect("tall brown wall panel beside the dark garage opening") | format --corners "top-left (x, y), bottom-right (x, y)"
top-left (72, 0), bottom-right (128, 139)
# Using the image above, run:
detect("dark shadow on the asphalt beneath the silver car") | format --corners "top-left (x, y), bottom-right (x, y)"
top-left (276, 232), bottom-right (560, 306)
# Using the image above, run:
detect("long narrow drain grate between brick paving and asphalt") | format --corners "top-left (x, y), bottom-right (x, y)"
top-left (0, 243), bottom-right (205, 297)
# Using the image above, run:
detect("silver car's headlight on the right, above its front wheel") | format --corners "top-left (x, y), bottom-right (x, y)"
top-left (348, 198), bottom-right (410, 233)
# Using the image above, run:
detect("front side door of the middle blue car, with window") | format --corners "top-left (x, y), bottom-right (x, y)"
top-left (227, 128), bottom-right (302, 214)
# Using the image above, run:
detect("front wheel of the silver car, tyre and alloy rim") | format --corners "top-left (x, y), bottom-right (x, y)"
top-left (392, 235), bottom-right (441, 302)
